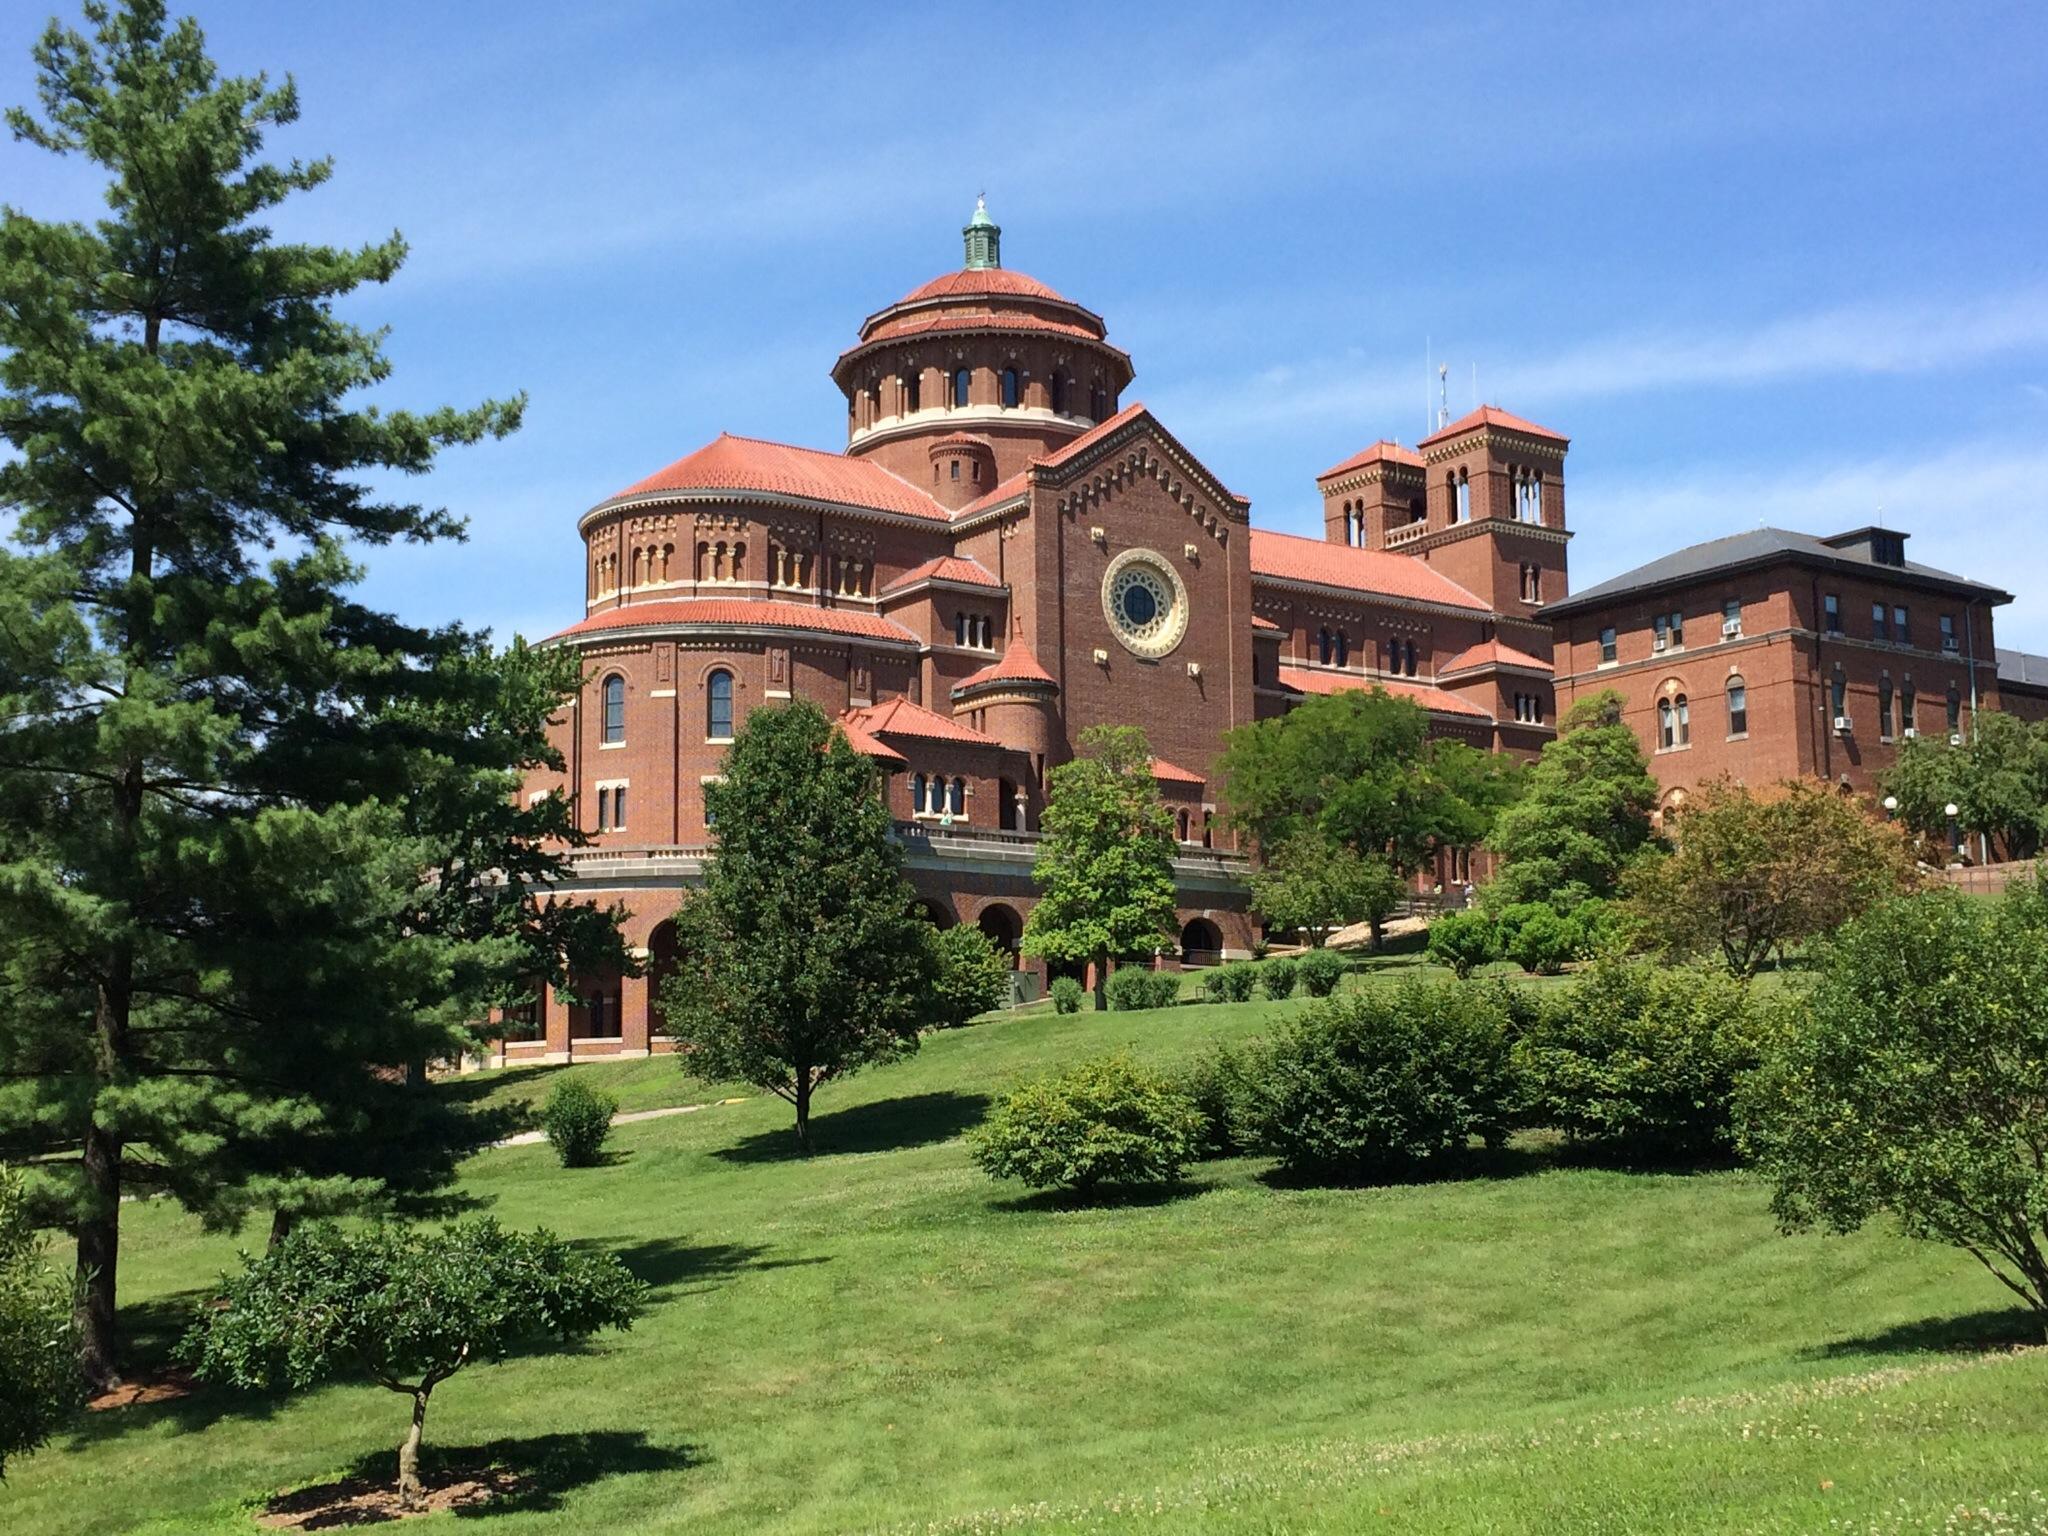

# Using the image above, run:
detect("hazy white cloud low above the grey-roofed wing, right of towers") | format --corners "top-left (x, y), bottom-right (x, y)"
top-left (1571, 440), bottom-right (2048, 651)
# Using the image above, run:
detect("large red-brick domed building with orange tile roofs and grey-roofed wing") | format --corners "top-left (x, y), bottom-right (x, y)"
top-left (504, 207), bottom-right (2048, 1061)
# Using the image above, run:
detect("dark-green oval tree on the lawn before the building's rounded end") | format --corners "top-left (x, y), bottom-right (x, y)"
top-left (662, 700), bottom-right (938, 1155)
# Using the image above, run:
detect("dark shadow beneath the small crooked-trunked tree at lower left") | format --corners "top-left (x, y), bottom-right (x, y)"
top-left (268, 1430), bottom-right (707, 1530)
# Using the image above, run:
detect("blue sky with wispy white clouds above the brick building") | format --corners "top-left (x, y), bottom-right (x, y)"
top-left (0, 0), bottom-right (2048, 651)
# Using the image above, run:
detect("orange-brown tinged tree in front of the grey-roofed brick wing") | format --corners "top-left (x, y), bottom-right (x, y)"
top-left (1630, 780), bottom-right (1919, 975)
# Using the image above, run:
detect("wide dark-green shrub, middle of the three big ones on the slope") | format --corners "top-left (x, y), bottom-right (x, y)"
top-left (1239, 981), bottom-right (1516, 1180)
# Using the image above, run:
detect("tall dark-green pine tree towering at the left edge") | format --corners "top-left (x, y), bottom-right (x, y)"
top-left (0, 0), bottom-right (614, 1384)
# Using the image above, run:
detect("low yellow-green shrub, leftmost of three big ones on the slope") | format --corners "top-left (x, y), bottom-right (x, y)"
top-left (969, 1057), bottom-right (1204, 1190)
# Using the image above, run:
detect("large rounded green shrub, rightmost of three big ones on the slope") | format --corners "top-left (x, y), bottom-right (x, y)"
top-left (1516, 954), bottom-right (1761, 1161)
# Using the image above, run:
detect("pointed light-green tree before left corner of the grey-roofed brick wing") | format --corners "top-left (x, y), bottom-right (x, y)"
top-left (1487, 690), bottom-right (1657, 909)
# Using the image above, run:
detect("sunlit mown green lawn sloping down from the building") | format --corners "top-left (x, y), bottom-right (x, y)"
top-left (12, 978), bottom-right (2048, 1536)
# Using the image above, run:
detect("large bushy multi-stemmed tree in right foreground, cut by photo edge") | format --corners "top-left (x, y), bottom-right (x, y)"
top-left (1737, 885), bottom-right (2048, 1329)
